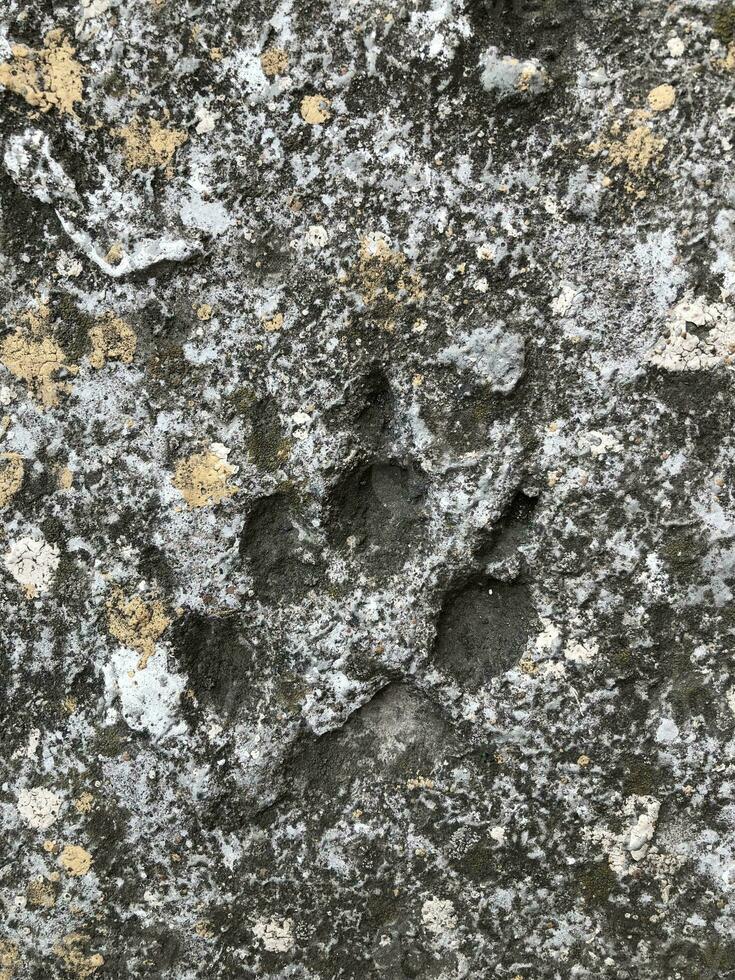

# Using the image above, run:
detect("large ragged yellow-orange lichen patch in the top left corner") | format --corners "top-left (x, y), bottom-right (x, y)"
top-left (0, 29), bottom-right (84, 116)
